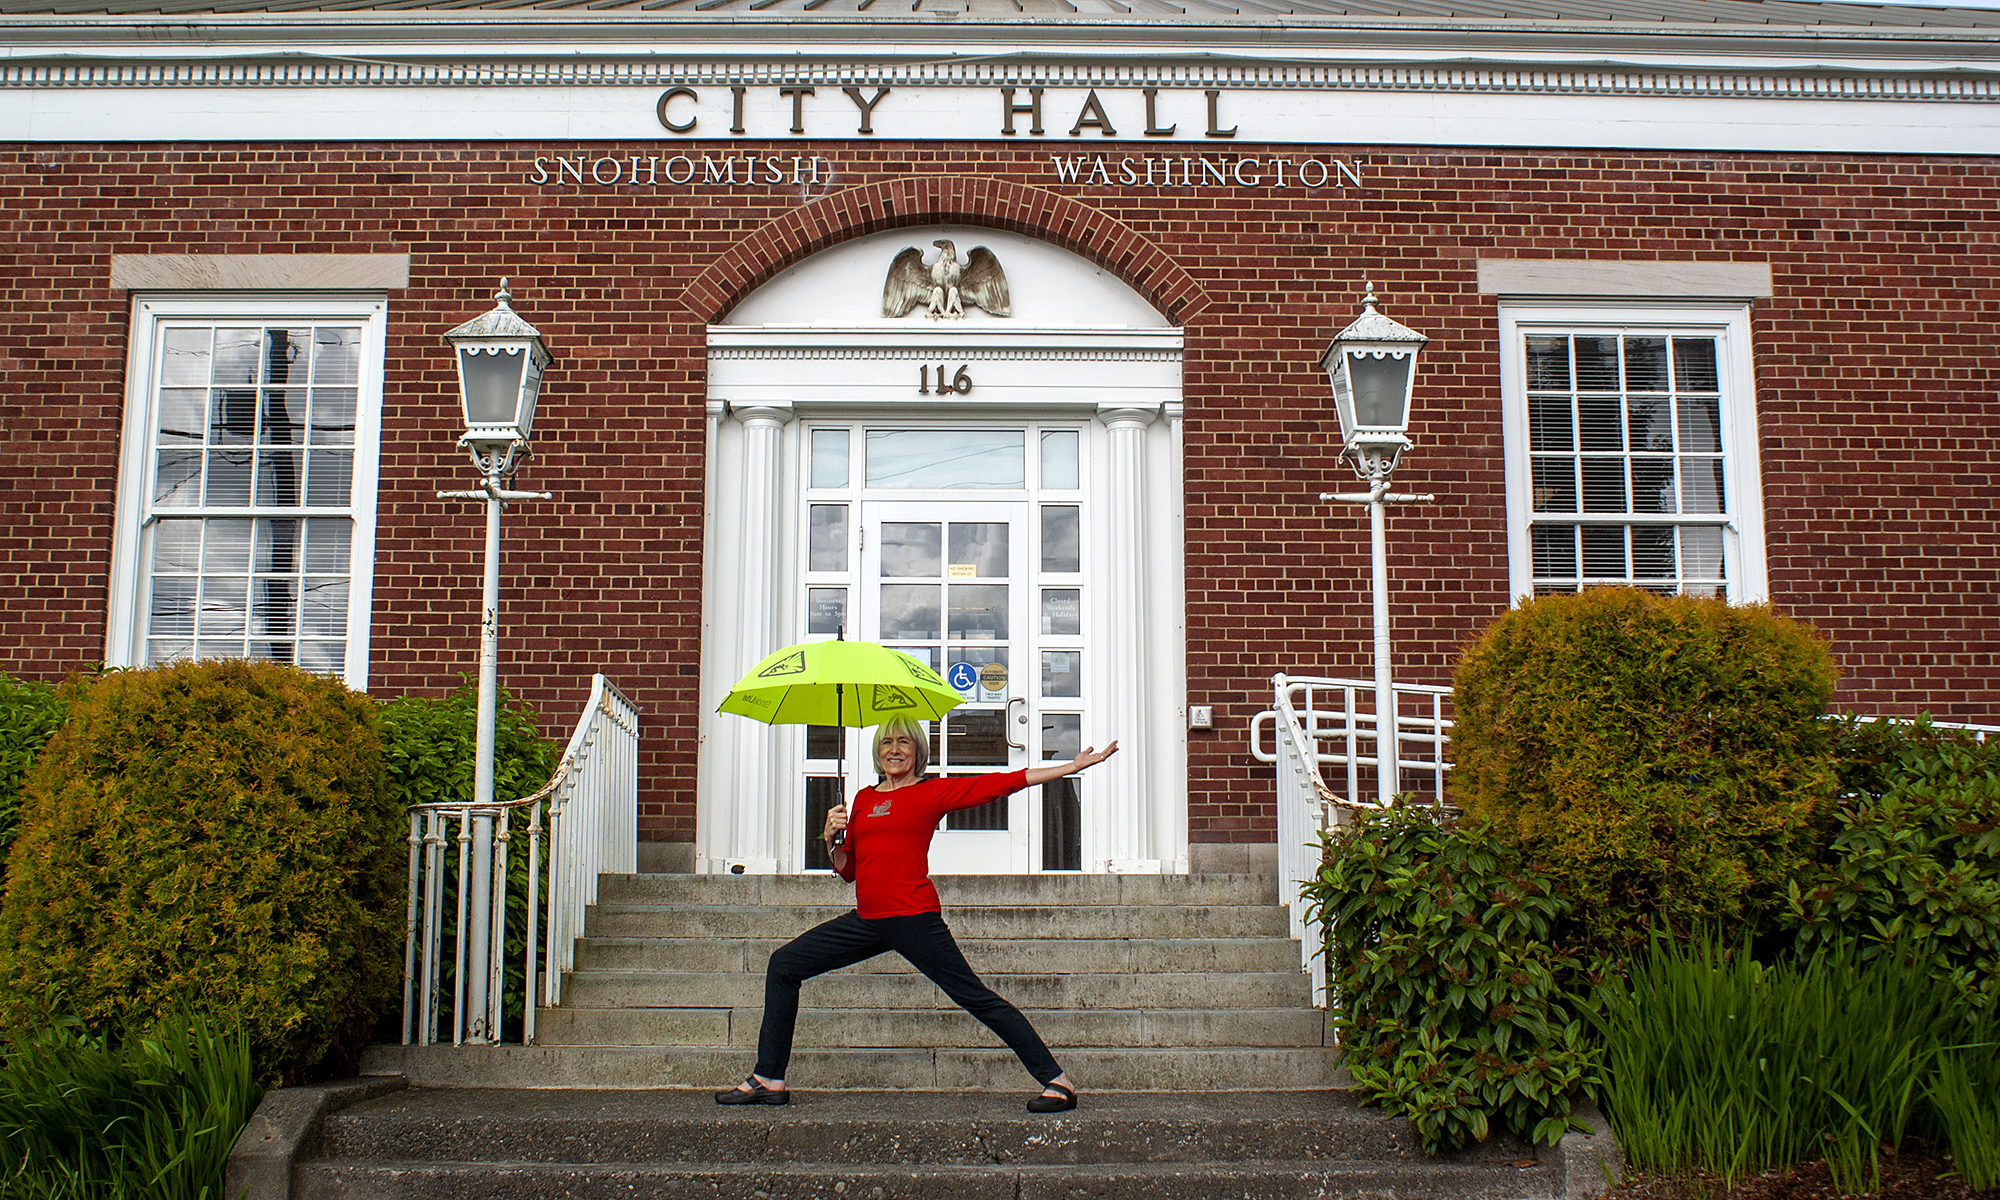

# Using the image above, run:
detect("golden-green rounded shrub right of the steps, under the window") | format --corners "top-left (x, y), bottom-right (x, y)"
top-left (1452, 588), bottom-right (1834, 950)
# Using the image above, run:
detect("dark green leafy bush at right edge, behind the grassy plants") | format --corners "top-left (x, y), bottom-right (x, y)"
top-left (1784, 722), bottom-right (2000, 1010)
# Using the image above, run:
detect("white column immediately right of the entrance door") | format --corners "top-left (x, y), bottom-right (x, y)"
top-left (1084, 404), bottom-right (1160, 872)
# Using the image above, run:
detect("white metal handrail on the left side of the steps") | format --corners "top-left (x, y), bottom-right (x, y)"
top-left (402, 674), bottom-right (638, 1046)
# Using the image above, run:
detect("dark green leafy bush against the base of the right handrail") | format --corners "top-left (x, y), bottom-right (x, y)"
top-left (1306, 808), bottom-right (1598, 1154)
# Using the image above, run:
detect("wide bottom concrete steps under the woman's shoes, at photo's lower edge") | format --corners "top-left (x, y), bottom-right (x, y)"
top-left (294, 1088), bottom-right (1566, 1200)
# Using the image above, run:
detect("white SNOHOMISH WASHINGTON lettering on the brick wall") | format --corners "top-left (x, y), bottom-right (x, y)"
top-left (528, 154), bottom-right (1362, 192)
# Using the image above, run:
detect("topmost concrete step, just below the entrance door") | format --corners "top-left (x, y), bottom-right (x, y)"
top-left (598, 874), bottom-right (1280, 910)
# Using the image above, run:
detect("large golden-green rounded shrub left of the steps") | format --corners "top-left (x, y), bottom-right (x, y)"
top-left (0, 660), bottom-right (404, 1082)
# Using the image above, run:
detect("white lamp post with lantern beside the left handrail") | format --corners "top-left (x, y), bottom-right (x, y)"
top-left (438, 280), bottom-right (554, 1046)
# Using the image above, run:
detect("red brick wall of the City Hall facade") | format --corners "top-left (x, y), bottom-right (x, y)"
top-left (0, 142), bottom-right (2000, 842)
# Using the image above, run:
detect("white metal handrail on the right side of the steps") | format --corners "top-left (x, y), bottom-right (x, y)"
top-left (1250, 674), bottom-right (1452, 1008)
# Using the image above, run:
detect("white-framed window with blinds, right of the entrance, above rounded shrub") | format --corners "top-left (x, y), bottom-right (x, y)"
top-left (1500, 302), bottom-right (1768, 604)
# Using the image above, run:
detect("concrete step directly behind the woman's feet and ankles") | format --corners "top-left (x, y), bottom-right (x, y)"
top-left (362, 1042), bottom-right (1348, 1094)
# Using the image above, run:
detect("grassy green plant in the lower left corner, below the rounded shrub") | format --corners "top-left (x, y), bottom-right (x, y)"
top-left (0, 1016), bottom-right (264, 1200)
